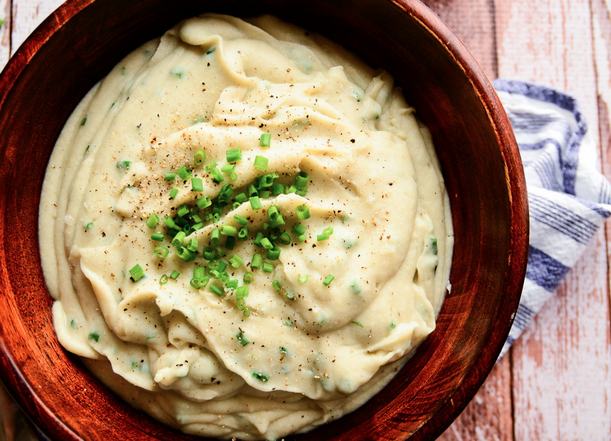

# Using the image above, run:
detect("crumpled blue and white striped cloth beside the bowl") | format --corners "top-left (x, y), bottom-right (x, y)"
top-left (494, 80), bottom-right (611, 356)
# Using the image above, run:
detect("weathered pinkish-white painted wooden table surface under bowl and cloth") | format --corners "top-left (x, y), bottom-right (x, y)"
top-left (0, 0), bottom-right (611, 441)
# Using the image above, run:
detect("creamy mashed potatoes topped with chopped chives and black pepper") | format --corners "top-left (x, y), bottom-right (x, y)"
top-left (40, 15), bottom-right (452, 439)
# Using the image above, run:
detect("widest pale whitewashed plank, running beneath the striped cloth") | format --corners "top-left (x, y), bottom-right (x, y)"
top-left (496, 0), bottom-right (611, 440)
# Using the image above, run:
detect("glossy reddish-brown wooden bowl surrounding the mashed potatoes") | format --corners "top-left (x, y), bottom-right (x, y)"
top-left (0, 0), bottom-right (528, 440)
